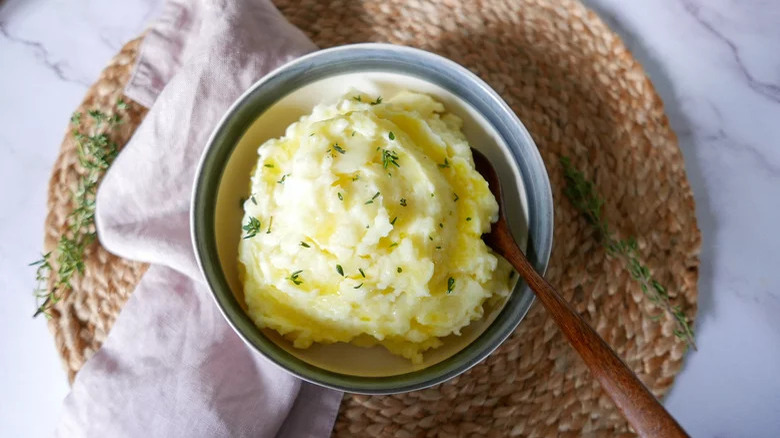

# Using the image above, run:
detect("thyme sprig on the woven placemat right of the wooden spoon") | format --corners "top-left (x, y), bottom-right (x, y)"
top-left (561, 157), bottom-right (697, 350)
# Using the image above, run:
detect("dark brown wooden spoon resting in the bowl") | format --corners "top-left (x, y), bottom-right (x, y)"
top-left (472, 149), bottom-right (688, 437)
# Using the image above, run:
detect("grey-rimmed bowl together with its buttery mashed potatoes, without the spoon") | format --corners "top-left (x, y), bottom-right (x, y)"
top-left (191, 44), bottom-right (553, 394)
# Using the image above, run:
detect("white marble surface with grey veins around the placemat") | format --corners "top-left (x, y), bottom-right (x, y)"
top-left (0, 0), bottom-right (780, 437)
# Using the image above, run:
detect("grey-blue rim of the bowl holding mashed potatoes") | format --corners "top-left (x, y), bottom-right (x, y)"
top-left (190, 43), bottom-right (553, 394)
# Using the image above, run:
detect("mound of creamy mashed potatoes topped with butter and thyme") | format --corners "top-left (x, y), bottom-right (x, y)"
top-left (239, 92), bottom-right (510, 363)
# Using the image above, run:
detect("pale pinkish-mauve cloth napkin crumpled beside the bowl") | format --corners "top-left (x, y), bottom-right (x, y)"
top-left (57, 0), bottom-right (342, 438)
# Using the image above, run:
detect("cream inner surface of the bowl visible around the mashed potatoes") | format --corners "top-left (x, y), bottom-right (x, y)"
top-left (215, 72), bottom-right (528, 377)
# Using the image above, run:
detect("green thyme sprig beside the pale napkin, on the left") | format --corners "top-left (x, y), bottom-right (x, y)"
top-left (30, 99), bottom-right (127, 317)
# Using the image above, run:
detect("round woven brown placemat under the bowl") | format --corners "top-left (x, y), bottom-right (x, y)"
top-left (45, 0), bottom-right (700, 437)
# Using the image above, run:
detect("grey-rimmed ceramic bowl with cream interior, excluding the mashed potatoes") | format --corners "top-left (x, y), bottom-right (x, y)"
top-left (191, 44), bottom-right (553, 394)
